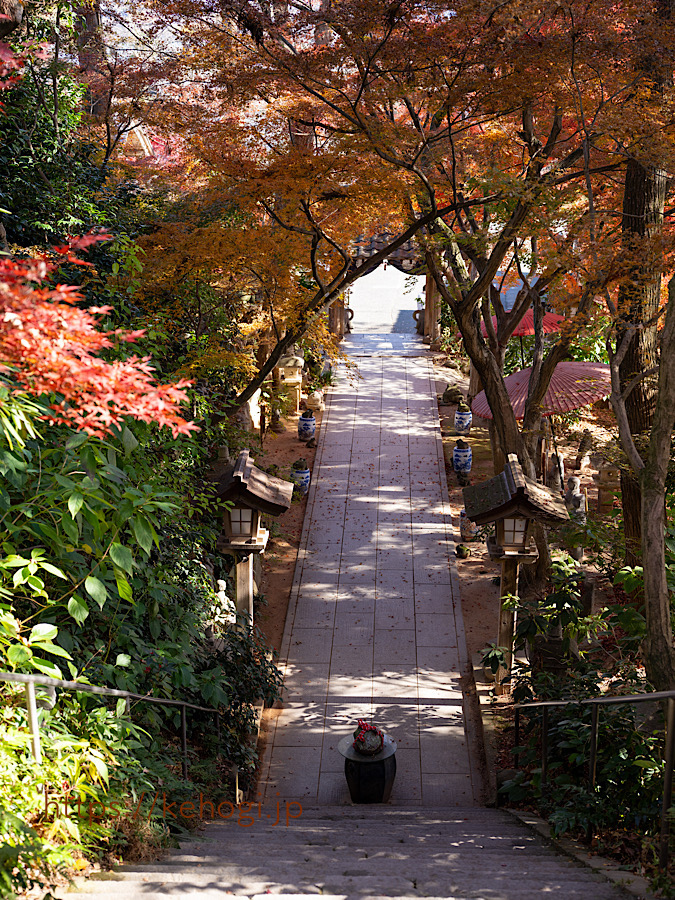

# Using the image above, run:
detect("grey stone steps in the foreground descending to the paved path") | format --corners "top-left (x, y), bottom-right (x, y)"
top-left (62, 802), bottom-right (628, 900)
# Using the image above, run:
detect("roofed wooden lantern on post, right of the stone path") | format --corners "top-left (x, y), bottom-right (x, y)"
top-left (463, 453), bottom-right (569, 693)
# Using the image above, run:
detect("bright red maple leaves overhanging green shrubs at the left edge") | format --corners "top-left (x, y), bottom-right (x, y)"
top-left (0, 234), bottom-right (197, 437)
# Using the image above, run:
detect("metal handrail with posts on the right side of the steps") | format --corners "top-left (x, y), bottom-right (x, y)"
top-left (513, 691), bottom-right (675, 871)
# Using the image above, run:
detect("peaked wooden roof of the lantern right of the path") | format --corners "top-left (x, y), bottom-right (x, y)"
top-left (462, 453), bottom-right (569, 525)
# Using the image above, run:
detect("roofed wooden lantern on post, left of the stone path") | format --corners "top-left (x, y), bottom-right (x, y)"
top-left (216, 450), bottom-right (293, 623)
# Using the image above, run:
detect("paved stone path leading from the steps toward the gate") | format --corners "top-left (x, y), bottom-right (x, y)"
top-left (260, 334), bottom-right (478, 807)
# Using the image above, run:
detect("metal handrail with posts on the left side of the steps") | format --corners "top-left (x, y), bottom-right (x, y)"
top-left (0, 672), bottom-right (226, 778)
